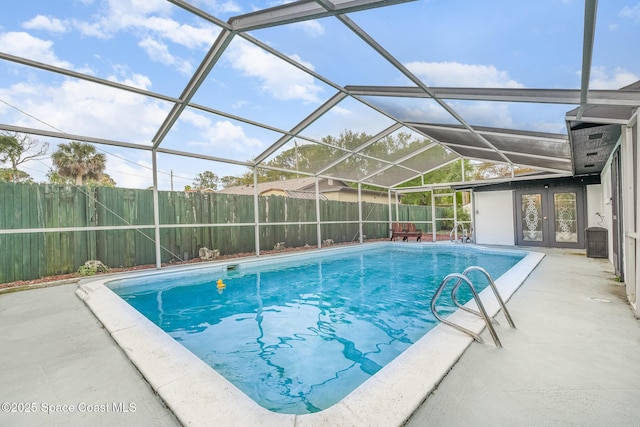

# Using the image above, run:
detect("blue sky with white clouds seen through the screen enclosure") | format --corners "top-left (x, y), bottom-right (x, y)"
top-left (0, 0), bottom-right (640, 190)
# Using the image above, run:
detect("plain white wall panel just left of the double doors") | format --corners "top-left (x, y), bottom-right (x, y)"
top-left (474, 190), bottom-right (515, 245)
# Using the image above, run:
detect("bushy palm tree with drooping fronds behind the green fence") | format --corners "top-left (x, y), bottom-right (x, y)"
top-left (51, 141), bottom-right (107, 185)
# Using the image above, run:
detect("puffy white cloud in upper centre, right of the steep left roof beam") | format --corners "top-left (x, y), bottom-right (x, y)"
top-left (228, 43), bottom-right (322, 103)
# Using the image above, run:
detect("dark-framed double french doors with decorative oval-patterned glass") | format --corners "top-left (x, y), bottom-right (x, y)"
top-left (515, 187), bottom-right (584, 248)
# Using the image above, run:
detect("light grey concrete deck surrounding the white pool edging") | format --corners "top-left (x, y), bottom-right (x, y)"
top-left (0, 249), bottom-right (640, 426)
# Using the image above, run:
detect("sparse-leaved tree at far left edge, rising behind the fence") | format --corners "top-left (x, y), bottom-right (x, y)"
top-left (0, 132), bottom-right (49, 182)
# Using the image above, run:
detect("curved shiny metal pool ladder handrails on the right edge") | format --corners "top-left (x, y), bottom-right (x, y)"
top-left (431, 265), bottom-right (516, 347)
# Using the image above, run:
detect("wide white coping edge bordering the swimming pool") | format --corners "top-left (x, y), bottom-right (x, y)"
top-left (76, 245), bottom-right (544, 426)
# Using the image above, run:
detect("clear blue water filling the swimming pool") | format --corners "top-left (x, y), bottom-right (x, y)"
top-left (109, 244), bottom-right (526, 414)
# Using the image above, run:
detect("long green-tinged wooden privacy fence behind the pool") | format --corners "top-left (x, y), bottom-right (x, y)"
top-left (0, 183), bottom-right (444, 283)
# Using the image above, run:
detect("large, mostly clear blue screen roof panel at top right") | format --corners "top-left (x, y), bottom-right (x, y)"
top-left (350, 1), bottom-right (584, 88)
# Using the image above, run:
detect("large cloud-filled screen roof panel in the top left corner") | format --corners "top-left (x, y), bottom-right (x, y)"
top-left (0, 1), bottom-right (220, 97)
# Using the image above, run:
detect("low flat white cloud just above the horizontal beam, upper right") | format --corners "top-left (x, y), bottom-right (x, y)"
top-left (405, 61), bottom-right (524, 88)
